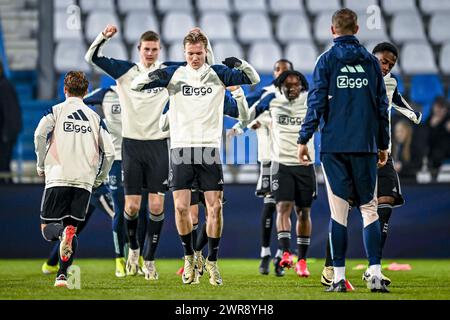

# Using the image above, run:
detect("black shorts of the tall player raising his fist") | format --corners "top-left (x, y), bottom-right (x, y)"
top-left (122, 138), bottom-right (169, 195)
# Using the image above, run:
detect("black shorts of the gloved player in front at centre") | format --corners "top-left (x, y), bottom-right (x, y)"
top-left (169, 147), bottom-right (223, 191)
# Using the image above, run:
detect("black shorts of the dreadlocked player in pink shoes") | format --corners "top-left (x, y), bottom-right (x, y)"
top-left (271, 162), bottom-right (317, 208)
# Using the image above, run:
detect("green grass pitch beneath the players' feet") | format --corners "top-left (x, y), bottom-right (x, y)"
top-left (0, 259), bottom-right (450, 300)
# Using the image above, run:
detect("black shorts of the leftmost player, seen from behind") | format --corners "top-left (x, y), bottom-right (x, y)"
top-left (41, 187), bottom-right (91, 224)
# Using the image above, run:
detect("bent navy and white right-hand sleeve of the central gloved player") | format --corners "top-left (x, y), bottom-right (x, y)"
top-left (211, 59), bottom-right (260, 87)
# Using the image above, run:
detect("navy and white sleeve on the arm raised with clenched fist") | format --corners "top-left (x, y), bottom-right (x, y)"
top-left (84, 33), bottom-right (135, 80)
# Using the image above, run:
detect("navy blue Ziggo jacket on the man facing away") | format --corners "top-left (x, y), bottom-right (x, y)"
top-left (298, 36), bottom-right (390, 153)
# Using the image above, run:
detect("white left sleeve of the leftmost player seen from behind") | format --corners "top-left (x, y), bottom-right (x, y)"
top-left (34, 109), bottom-right (56, 172)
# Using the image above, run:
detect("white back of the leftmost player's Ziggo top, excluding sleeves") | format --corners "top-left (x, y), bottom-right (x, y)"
top-left (45, 97), bottom-right (103, 190)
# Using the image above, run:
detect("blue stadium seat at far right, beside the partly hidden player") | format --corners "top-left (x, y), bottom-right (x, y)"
top-left (409, 74), bottom-right (444, 120)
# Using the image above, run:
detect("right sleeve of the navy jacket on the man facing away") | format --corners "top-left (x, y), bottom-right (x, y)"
top-left (374, 63), bottom-right (391, 150)
